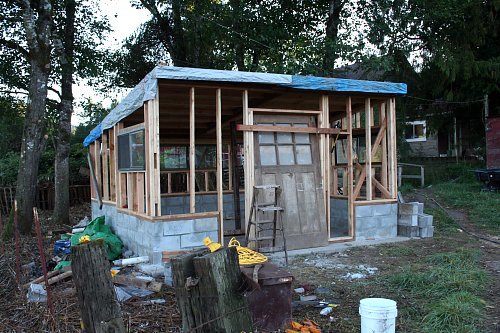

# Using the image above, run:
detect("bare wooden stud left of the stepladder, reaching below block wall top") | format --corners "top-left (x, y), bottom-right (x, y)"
top-left (215, 89), bottom-right (224, 245)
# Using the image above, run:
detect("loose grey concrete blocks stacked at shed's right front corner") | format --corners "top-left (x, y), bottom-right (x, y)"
top-left (398, 202), bottom-right (434, 238)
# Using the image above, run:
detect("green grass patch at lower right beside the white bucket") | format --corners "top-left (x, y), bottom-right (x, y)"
top-left (380, 249), bottom-right (489, 332)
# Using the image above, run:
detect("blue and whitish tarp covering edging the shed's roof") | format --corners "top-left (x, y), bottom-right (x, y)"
top-left (83, 66), bottom-right (406, 146)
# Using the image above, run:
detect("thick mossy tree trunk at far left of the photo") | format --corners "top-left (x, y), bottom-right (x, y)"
top-left (16, 0), bottom-right (52, 234)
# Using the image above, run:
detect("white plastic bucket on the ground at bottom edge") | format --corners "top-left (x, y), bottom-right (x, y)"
top-left (359, 298), bottom-right (398, 333)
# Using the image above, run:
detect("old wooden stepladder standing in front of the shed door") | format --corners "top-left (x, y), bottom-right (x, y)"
top-left (245, 184), bottom-right (288, 265)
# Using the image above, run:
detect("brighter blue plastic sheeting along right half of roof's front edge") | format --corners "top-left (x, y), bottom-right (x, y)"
top-left (280, 75), bottom-right (406, 95)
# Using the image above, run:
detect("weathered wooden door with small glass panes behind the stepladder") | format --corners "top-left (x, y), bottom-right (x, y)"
top-left (254, 115), bottom-right (328, 249)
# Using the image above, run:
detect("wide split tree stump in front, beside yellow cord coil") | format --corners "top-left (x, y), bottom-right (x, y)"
top-left (171, 248), bottom-right (252, 332)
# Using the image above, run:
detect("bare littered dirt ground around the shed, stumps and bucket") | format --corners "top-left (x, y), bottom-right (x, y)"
top-left (0, 191), bottom-right (500, 332)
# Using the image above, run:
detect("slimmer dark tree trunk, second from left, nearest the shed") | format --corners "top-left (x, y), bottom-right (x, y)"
top-left (53, 0), bottom-right (76, 224)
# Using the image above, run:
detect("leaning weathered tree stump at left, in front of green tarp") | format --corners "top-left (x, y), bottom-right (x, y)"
top-left (71, 240), bottom-right (125, 333)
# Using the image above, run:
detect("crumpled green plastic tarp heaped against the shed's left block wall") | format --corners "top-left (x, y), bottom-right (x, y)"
top-left (71, 216), bottom-right (123, 260)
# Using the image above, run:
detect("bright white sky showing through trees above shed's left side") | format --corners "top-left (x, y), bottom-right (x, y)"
top-left (71, 0), bottom-right (151, 125)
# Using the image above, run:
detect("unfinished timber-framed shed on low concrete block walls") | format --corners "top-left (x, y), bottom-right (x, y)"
top-left (84, 66), bottom-right (406, 263)
